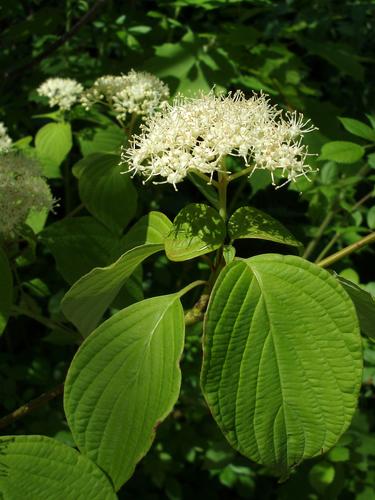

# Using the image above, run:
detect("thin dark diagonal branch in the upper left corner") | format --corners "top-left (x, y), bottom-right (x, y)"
top-left (3, 0), bottom-right (107, 80)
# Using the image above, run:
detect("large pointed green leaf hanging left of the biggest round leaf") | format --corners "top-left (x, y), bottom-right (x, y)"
top-left (64, 293), bottom-right (185, 490)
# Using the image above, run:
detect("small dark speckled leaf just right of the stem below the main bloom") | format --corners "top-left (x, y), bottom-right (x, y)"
top-left (228, 207), bottom-right (302, 247)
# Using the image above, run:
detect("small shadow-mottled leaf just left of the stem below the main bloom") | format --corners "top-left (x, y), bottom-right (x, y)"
top-left (165, 203), bottom-right (226, 262)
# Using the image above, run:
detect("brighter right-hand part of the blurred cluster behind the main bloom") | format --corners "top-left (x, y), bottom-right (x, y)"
top-left (113, 70), bottom-right (169, 119)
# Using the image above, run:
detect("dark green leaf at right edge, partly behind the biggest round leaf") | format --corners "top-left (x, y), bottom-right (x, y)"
top-left (336, 276), bottom-right (375, 340)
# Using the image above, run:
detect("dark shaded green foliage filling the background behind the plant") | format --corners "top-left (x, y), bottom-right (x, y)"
top-left (0, 0), bottom-right (375, 500)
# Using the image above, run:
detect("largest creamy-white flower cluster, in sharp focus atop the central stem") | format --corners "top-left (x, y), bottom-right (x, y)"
top-left (121, 92), bottom-right (314, 188)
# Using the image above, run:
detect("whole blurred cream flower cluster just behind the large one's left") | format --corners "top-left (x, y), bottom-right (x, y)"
top-left (81, 70), bottom-right (169, 120)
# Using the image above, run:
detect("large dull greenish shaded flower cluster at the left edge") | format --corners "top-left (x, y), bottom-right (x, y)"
top-left (0, 153), bottom-right (53, 239)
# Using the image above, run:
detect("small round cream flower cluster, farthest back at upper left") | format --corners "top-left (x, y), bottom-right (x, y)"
top-left (37, 78), bottom-right (83, 111)
